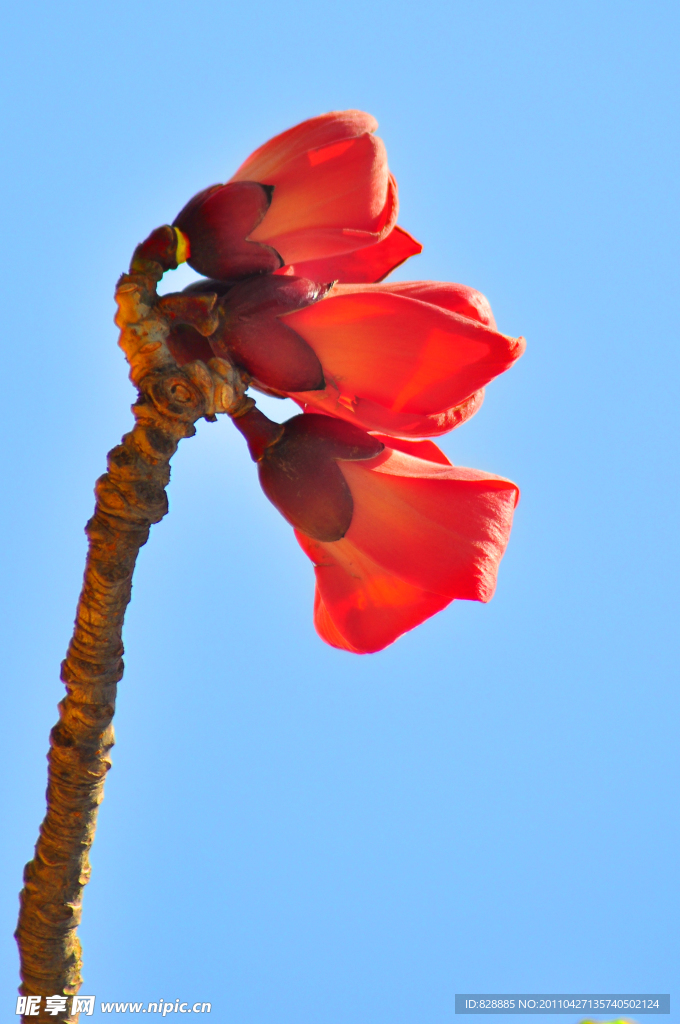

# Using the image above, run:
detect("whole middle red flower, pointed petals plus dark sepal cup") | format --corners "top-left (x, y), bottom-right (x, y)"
top-left (170, 275), bottom-right (524, 437)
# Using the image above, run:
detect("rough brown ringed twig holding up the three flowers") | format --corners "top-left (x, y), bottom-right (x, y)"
top-left (16, 235), bottom-right (252, 1021)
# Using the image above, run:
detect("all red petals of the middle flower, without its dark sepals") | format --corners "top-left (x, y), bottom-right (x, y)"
top-left (285, 281), bottom-right (525, 437)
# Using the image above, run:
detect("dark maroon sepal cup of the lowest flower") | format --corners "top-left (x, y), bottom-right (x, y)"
top-left (235, 414), bottom-right (384, 542)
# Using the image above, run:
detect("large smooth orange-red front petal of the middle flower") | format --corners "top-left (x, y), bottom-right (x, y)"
top-left (285, 285), bottom-right (524, 416)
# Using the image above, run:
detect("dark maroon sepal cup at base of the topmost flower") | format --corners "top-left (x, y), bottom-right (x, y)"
top-left (174, 181), bottom-right (284, 281)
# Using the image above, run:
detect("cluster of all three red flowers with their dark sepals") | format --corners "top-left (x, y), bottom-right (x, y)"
top-left (161, 111), bottom-right (524, 653)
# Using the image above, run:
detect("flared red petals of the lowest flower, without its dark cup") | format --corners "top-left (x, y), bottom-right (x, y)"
top-left (288, 437), bottom-right (518, 653)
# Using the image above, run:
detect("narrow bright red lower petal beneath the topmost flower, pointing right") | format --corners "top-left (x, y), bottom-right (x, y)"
top-left (274, 225), bottom-right (423, 284)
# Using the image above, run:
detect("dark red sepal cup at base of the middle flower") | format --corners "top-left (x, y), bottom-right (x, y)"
top-left (210, 274), bottom-right (329, 392)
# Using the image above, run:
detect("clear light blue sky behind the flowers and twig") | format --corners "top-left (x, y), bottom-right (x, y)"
top-left (0, 0), bottom-right (680, 1024)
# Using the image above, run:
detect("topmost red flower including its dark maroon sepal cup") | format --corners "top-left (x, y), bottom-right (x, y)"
top-left (174, 111), bottom-right (422, 281)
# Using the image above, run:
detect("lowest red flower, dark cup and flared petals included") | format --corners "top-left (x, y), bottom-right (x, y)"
top-left (235, 411), bottom-right (518, 653)
